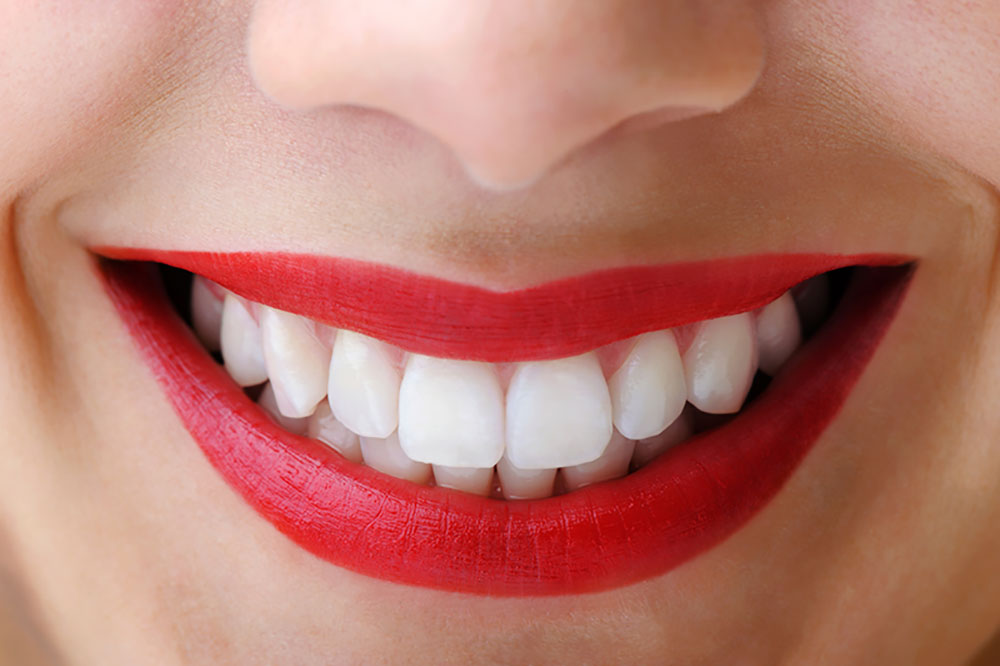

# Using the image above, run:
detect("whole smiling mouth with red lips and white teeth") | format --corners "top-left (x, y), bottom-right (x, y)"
top-left (95, 248), bottom-right (914, 596)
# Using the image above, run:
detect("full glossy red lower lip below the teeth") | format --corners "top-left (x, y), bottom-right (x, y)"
top-left (100, 261), bottom-right (912, 596)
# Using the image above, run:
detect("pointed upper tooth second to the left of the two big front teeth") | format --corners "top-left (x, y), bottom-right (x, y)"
top-left (260, 307), bottom-right (330, 417)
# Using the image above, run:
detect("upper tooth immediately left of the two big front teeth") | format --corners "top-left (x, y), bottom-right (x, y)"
top-left (328, 330), bottom-right (399, 438)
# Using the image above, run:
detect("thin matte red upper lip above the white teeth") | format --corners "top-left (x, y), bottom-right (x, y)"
top-left (95, 247), bottom-right (908, 362)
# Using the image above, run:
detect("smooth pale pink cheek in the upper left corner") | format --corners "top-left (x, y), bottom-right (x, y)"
top-left (0, 0), bottom-right (193, 194)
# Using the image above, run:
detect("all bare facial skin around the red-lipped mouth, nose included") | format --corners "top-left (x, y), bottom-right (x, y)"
top-left (0, 0), bottom-right (1000, 664)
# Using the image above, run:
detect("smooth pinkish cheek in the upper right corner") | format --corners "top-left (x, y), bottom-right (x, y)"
top-left (839, 0), bottom-right (1000, 186)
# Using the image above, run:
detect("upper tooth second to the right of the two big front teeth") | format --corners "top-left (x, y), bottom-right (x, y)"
top-left (684, 312), bottom-right (757, 414)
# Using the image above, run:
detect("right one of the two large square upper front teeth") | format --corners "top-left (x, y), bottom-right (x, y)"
top-left (506, 352), bottom-right (612, 469)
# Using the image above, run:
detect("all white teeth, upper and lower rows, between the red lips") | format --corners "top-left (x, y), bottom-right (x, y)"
top-left (203, 268), bottom-right (830, 492)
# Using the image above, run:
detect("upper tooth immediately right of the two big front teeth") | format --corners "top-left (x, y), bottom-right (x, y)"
top-left (608, 331), bottom-right (687, 439)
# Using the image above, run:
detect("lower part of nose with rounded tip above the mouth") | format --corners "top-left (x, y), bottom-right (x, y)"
top-left (248, 0), bottom-right (764, 187)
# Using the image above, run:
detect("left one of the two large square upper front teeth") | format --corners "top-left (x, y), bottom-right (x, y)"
top-left (399, 354), bottom-right (504, 468)
